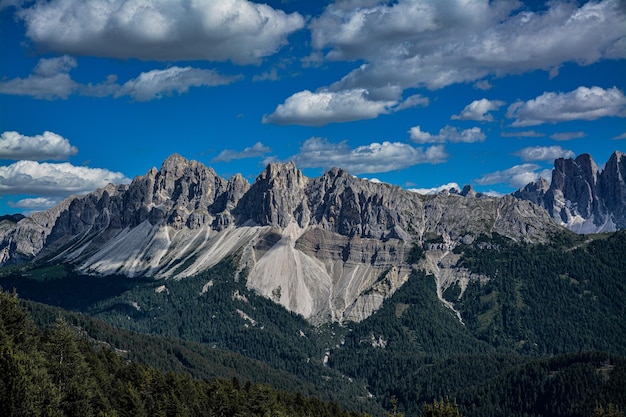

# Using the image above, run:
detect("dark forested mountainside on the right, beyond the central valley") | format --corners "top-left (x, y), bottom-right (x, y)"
top-left (329, 232), bottom-right (626, 416)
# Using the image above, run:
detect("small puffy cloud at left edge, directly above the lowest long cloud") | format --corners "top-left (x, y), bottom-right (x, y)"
top-left (0, 131), bottom-right (78, 161)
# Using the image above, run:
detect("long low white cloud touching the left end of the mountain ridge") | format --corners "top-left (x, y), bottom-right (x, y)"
top-left (0, 160), bottom-right (130, 198)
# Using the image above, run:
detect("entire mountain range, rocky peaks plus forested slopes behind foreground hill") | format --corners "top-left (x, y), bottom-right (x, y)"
top-left (0, 152), bottom-right (626, 417)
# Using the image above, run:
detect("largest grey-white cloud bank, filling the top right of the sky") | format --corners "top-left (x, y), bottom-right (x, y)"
top-left (310, 0), bottom-right (626, 90)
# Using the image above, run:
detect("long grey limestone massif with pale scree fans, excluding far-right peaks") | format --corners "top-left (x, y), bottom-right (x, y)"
top-left (0, 155), bottom-right (560, 323)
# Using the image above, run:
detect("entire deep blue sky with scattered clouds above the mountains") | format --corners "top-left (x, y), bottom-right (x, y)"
top-left (0, 0), bottom-right (626, 214)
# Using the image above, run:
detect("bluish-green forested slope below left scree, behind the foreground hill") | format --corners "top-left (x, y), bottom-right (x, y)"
top-left (0, 260), bottom-right (376, 405)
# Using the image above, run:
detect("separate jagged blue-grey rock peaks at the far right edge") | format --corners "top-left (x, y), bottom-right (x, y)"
top-left (513, 152), bottom-right (626, 233)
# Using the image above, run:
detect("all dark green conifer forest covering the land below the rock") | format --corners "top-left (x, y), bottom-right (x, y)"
top-left (0, 231), bottom-right (626, 417)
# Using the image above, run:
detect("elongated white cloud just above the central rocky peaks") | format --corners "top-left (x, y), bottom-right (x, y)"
top-left (291, 138), bottom-right (448, 174)
